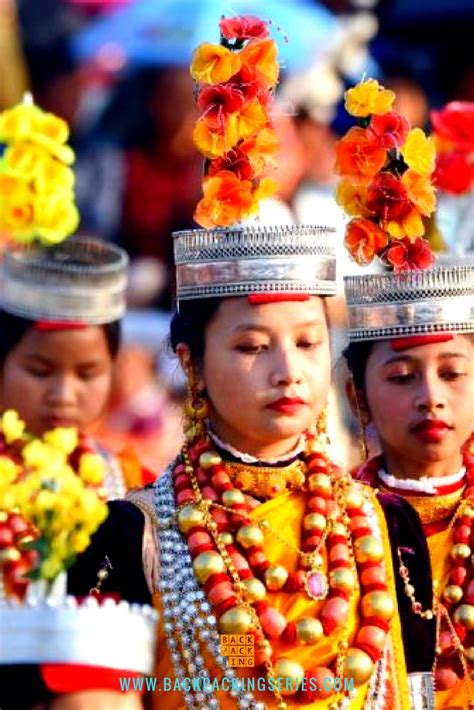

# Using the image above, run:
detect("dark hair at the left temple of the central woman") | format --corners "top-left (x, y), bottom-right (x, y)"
top-left (170, 298), bottom-right (222, 362)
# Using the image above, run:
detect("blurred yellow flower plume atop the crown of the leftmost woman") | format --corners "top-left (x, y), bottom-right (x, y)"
top-left (0, 98), bottom-right (79, 244)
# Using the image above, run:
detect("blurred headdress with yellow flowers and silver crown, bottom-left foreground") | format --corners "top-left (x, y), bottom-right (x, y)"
top-left (0, 411), bottom-right (157, 680)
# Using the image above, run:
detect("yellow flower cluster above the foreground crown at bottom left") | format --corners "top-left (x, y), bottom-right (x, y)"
top-left (0, 411), bottom-right (107, 591)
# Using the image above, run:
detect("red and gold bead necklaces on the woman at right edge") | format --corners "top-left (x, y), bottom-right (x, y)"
top-left (366, 449), bottom-right (474, 708)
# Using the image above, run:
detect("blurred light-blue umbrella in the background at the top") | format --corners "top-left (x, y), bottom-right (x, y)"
top-left (72, 0), bottom-right (337, 71)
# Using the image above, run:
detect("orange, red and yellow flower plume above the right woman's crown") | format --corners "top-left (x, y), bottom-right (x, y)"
top-left (336, 79), bottom-right (436, 271)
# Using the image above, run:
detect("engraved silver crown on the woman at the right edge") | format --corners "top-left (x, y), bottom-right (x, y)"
top-left (344, 268), bottom-right (474, 342)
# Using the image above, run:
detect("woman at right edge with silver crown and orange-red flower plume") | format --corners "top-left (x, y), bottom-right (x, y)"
top-left (337, 80), bottom-right (474, 708)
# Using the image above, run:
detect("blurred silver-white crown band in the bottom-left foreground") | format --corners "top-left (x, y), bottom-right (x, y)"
top-left (0, 596), bottom-right (158, 674)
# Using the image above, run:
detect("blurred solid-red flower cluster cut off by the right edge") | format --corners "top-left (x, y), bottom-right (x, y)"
top-left (431, 101), bottom-right (474, 195)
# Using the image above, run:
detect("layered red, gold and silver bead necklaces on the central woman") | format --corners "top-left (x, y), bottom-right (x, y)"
top-left (156, 436), bottom-right (394, 708)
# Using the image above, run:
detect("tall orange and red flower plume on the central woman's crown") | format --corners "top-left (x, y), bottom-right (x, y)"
top-left (190, 17), bottom-right (279, 228)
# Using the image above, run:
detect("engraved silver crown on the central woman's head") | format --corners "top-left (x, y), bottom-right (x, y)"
top-left (173, 225), bottom-right (336, 301)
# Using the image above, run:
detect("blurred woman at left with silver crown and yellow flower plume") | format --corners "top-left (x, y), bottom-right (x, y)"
top-left (0, 98), bottom-right (156, 498)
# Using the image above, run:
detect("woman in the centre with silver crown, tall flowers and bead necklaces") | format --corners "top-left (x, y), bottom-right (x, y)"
top-left (65, 18), bottom-right (416, 710)
